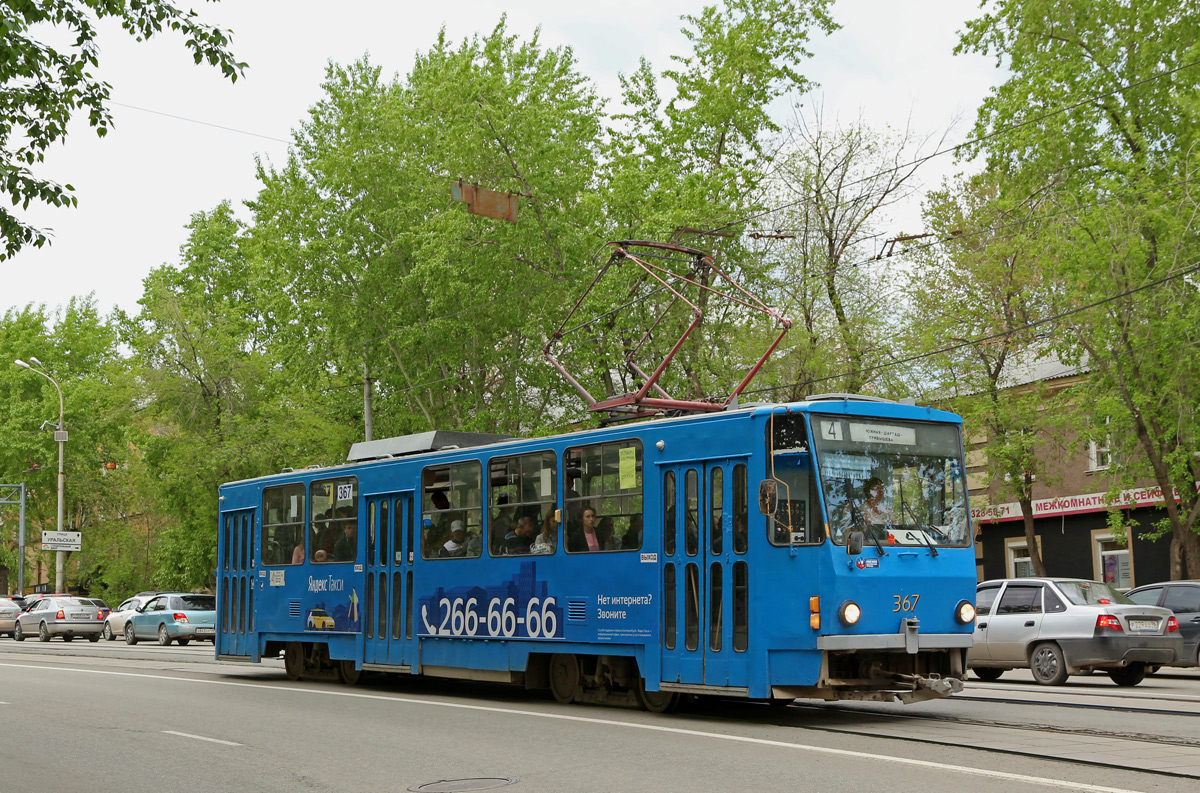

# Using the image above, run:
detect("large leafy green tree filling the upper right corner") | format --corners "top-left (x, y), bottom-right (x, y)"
top-left (959, 0), bottom-right (1200, 578)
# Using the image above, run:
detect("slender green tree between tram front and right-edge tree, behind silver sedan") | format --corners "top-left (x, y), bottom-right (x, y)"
top-left (902, 173), bottom-right (1066, 576)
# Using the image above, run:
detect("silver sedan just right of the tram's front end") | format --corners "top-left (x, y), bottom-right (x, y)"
top-left (967, 578), bottom-right (1183, 686)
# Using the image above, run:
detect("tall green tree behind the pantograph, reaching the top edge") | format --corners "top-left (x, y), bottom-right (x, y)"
top-left (593, 0), bottom-right (838, 407)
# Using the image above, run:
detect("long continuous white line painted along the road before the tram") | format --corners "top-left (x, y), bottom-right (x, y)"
top-left (0, 663), bottom-right (1156, 793)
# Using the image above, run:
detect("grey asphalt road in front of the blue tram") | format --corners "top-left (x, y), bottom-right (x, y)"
top-left (0, 639), bottom-right (1200, 793)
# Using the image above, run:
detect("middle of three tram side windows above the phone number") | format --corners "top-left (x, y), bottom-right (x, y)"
top-left (487, 451), bottom-right (558, 557)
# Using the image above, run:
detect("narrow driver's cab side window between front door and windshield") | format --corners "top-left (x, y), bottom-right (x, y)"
top-left (767, 414), bottom-right (823, 545)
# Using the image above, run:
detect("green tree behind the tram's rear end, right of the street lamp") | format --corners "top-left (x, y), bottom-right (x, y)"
top-left (124, 204), bottom-right (347, 587)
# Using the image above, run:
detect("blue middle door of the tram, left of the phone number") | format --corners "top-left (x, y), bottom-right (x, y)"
top-left (362, 491), bottom-right (413, 666)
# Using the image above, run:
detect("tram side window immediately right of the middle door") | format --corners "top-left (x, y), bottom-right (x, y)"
top-left (421, 459), bottom-right (484, 559)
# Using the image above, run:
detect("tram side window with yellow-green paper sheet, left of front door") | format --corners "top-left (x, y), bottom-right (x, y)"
top-left (563, 439), bottom-right (643, 553)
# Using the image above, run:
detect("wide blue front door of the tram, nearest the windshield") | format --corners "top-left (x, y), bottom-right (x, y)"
top-left (662, 459), bottom-right (749, 687)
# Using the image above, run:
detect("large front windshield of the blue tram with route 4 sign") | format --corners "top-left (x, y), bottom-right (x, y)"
top-left (812, 415), bottom-right (971, 547)
